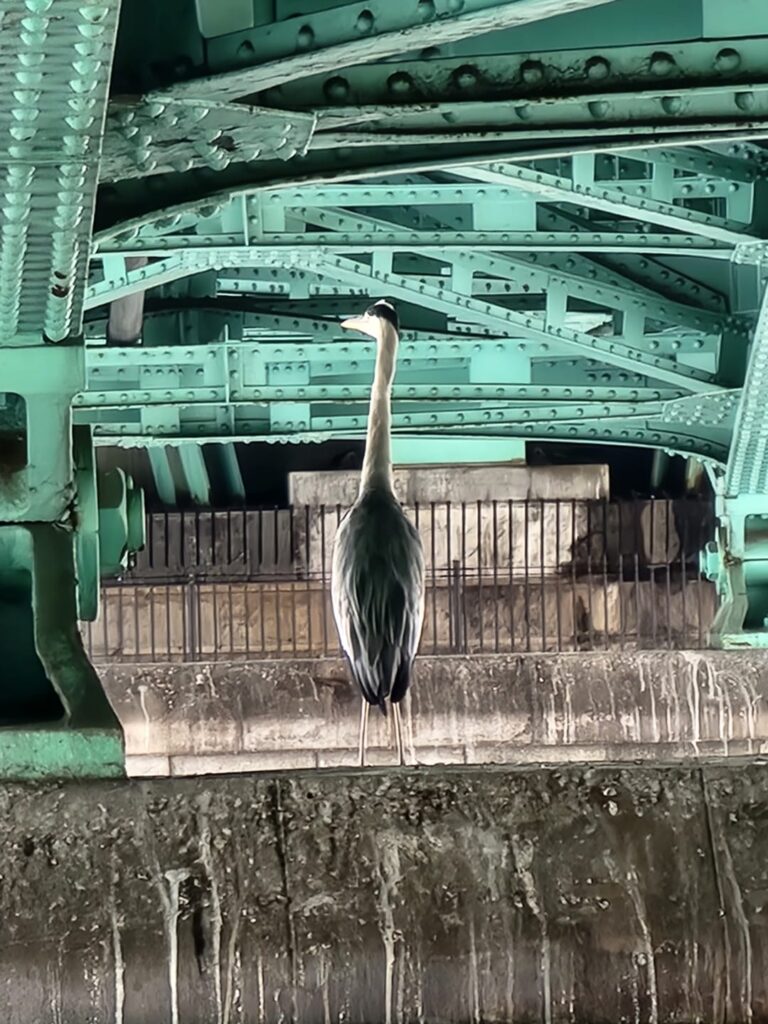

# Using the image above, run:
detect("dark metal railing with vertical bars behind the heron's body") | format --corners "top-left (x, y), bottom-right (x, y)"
top-left (84, 500), bottom-right (716, 662)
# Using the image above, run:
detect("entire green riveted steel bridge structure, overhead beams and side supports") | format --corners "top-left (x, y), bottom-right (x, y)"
top-left (0, 0), bottom-right (768, 774)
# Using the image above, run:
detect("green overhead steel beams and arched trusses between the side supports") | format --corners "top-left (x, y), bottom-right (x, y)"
top-left (3, 0), bottom-right (768, 507)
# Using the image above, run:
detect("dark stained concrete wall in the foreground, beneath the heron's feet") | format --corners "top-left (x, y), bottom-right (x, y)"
top-left (0, 764), bottom-right (768, 1024)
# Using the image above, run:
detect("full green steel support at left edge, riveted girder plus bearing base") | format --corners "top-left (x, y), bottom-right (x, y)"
top-left (0, 0), bottom-right (128, 777)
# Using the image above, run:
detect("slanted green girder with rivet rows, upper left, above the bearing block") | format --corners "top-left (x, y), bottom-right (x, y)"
top-left (0, 0), bottom-right (120, 345)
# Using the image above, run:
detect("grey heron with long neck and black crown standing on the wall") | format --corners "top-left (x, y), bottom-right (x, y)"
top-left (331, 299), bottom-right (424, 765)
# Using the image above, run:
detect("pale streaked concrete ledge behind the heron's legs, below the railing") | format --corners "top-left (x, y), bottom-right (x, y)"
top-left (102, 651), bottom-right (768, 775)
